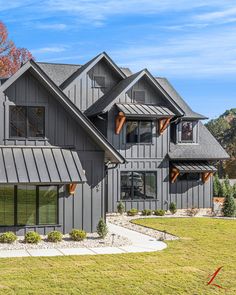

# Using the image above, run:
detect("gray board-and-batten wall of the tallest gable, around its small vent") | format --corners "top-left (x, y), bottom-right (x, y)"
top-left (63, 58), bottom-right (122, 111)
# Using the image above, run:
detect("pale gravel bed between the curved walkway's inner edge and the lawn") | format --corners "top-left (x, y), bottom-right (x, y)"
top-left (107, 214), bottom-right (179, 240)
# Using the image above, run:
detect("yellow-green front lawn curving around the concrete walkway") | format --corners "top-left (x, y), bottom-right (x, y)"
top-left (0, 218), bottom-right (236, 295)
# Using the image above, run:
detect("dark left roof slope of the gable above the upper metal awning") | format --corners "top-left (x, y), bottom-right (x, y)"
top-left (84, 71), bottom-right (142, 116)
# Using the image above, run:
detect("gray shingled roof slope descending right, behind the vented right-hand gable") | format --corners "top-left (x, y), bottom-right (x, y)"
top-left (156, 77), bottom-right (207, 119)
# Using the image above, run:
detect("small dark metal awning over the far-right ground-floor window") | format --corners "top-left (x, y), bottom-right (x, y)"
top-left (171, 161), bottom-right (217, 173)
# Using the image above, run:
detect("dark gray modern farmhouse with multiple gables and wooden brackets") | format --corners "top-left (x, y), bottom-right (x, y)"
top-left (0, 53), bottom-right (228, 235)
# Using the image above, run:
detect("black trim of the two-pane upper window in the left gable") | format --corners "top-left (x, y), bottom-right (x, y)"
top-left (8, 104), bottom-right (46, 140)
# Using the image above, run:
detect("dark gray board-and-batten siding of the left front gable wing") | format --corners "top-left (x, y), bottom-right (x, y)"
top-left (0, 72), bottom-right (105, 235)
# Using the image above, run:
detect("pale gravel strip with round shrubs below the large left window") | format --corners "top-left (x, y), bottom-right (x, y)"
top-left (0, 233), bottom-right (131, 250)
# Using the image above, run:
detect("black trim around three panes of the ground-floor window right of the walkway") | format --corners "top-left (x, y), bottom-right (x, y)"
top-left (120, 170), bottom-right (158, 202)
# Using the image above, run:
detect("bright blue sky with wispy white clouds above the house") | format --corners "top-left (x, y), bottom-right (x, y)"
top-left (0, 0), bottom-right (236, 118)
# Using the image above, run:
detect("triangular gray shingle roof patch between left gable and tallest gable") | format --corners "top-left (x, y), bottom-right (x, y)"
top-left (37, 62), bottom-right (81, 86)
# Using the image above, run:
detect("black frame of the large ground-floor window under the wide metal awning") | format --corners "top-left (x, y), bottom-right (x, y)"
top-left (0, 184), bottom-right (59, 227)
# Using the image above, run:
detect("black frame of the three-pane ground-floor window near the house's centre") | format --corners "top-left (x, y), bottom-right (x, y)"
top-left (120, 170), bottom-right (158, 202)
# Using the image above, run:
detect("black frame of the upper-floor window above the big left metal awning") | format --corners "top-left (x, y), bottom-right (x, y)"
top-left (9, 105), bottom-right (46, 139)
